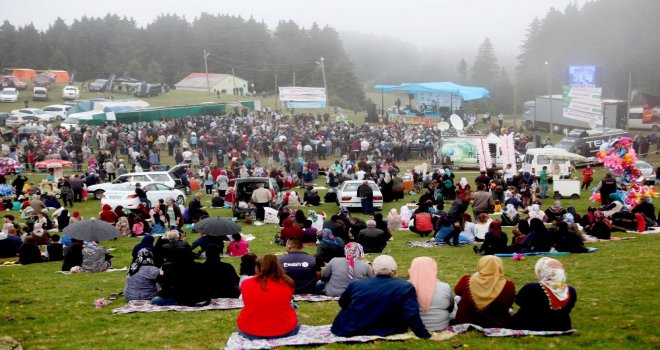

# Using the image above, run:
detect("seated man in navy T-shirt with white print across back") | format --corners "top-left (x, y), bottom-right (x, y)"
top-left (279, 238), bottom-right (321, 294)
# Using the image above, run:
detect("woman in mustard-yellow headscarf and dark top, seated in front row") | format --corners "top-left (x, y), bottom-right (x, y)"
top-left (454, 255), bottom-right (516, 328)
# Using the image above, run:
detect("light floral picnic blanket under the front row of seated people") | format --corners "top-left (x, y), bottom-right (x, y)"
top-left (225, 323), bottom-right (574, 350)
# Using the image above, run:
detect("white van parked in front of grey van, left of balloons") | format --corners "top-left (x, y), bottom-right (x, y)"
top-left (521, 147), bottom-right (587, 179)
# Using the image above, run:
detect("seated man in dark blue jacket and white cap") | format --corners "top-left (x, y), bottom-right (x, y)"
top-left (331, 255), bottom-right (431, 338)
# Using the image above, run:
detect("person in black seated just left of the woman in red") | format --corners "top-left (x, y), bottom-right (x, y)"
top-left (201, 243), bottom-right (241, 298)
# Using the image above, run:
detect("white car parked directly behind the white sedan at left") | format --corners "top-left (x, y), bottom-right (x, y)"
top-left (87, 165), bottom-right (185, 199)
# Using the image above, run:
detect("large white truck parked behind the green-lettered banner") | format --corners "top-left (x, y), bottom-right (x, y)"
top-left (522, 95), bottom-right (628, 135)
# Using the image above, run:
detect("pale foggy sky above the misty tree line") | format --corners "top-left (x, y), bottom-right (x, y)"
top-left (0, 0), bottom-right (587, 56)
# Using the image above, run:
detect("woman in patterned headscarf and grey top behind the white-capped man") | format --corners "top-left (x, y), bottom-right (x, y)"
top-left (321, 242), bottom-right (374, 297)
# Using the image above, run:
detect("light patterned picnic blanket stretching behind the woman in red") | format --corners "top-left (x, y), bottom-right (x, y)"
top-left (112, 294), bottom-right (339, 315)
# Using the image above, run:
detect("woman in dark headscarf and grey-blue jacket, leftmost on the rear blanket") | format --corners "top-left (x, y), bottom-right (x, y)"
top-left (124, 249), bottom-right (160, 301)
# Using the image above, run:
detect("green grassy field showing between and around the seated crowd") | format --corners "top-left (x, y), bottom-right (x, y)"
top-left (0, 163), bottom-right (660, 349)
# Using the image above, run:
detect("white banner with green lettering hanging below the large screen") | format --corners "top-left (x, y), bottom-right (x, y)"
top-left (562, 85), bottom-right (603, 127)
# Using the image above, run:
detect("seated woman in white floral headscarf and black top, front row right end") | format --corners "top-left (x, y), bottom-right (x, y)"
top-left (513, 257), bottom-right (577, 331)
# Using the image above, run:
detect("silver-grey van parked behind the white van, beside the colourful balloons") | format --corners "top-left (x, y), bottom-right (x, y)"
top-left (555, 128), bottom-right (630, 158)
